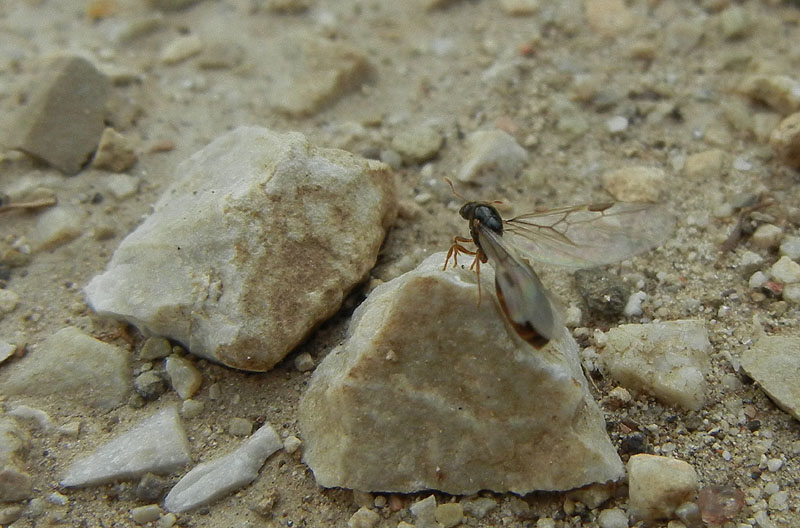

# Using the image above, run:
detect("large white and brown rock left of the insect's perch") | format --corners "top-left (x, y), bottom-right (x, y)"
top-left (86, 127), bottom-right (396, 371)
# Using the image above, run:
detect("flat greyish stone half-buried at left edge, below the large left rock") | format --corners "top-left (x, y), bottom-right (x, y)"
top-left (0, 326), bottom-right (132, 408)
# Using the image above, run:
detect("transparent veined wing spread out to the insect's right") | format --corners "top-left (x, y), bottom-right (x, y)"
top-left (503, 202), bottom-right (675, 268)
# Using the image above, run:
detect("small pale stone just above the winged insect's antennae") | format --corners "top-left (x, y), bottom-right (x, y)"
top-left (457, 130), bottom-right (528, 182)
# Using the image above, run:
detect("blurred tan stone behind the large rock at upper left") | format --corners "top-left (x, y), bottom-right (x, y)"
top-left (264, 33), bottom-right (372, 116)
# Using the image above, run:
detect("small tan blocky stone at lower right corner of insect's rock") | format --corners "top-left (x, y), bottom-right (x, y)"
top-left (628, 454), bottom-right (697, 521)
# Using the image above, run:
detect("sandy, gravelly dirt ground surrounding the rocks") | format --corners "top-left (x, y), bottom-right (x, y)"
top-left (0, 0), bottom-right (800, 527)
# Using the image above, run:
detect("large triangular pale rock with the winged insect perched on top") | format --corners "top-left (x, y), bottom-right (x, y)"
top-left (299, 253), bottom-right (623, 494)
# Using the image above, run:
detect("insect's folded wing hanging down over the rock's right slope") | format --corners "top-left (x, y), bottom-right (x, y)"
top-left (478, 225), bottom-right (563, 348)
